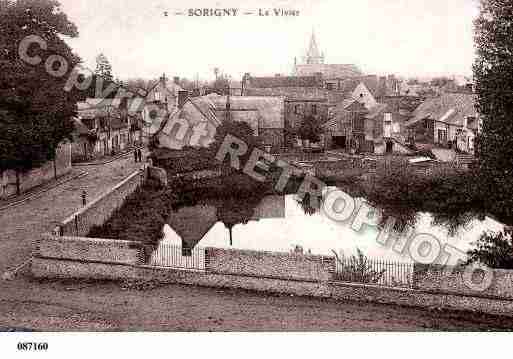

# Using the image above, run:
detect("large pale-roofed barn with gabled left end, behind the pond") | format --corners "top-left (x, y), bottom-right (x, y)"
top-left (154, 92), bottom-right (285, 151)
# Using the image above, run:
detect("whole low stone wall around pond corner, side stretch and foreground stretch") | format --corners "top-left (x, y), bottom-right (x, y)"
top-left (31, 165), bottom-right (513, 316)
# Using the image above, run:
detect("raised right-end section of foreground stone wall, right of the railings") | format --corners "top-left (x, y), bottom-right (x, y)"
top-left (415, 264), bottom-right (513, 299)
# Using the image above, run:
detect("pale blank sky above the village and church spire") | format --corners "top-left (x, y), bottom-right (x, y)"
top-left (59, 0), bottom-right (479, 80)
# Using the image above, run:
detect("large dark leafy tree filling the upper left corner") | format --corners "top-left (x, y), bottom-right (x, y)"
top-left (0, 0), bottom-right (80, 192)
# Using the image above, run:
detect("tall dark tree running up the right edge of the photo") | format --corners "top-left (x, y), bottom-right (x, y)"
top-left (474, 0), bottom-right (513, 225)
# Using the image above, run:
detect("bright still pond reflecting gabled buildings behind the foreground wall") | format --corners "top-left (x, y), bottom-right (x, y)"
top-left (161, 189), bottom-right (503, 264)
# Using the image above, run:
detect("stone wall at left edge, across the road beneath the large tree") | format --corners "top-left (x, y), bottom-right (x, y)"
top-left (0, 143), bottom-right (71, 199)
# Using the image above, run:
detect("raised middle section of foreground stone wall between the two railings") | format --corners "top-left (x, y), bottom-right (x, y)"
top-left (206, 248), bottom-right (335, 281)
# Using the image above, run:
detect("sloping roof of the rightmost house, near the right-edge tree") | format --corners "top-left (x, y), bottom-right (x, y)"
top-left (406, 93), bottom-right (477, 126)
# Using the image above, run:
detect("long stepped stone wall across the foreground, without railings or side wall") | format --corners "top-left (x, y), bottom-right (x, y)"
top-left (31, 235), bottom-right (513, 316)
